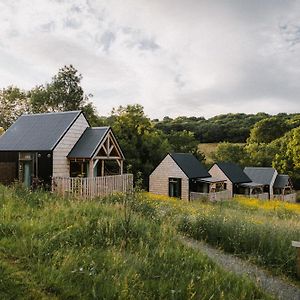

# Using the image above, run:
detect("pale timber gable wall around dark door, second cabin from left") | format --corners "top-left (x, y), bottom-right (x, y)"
top-left (149, 155), bottom-right (189, 200)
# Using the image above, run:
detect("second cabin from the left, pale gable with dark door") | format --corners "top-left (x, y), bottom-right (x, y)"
top-left (149, 153), bottom-right (227, 200)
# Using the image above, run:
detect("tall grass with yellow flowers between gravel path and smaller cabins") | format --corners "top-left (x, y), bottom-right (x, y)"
top-left (132, 194), bottom-right (300, 279)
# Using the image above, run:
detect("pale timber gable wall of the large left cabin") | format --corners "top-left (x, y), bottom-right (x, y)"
top-left (53, 114), bottom-right (89, 177)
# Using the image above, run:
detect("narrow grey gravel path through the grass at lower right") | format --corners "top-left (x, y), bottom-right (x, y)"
top-left (179, 236), bottom-right (300, 300)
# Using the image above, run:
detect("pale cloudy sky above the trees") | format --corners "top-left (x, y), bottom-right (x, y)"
top-left (0, 0), bottom-right (300, 119)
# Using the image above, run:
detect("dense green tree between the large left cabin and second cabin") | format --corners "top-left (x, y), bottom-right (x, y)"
top-left (109, 104), bottom-right (170, 183)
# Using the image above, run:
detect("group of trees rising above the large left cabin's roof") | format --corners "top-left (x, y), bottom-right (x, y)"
top-left (0, 65), bottom-right (98, 130)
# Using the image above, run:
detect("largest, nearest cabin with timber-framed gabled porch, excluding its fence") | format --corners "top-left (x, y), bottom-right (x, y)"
top-left (0, 111), bottom-right (124, 187)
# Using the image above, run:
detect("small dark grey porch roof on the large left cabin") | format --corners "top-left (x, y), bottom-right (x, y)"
top-left (68, 127), bottom-right (110, 158)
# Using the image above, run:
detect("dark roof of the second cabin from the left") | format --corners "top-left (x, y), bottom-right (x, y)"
top-left (170, 153), bottom-right (211, 178)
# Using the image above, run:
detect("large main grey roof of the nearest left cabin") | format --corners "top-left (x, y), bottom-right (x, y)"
top-left (0, 111), bottom-right (81, 151)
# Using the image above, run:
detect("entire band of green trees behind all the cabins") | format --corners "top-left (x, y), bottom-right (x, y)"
top-left (0, 65), bottom-right (300, 185)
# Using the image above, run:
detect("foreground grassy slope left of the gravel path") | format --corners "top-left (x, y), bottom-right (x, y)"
top-left (0, 186), bottom-right (269, 299)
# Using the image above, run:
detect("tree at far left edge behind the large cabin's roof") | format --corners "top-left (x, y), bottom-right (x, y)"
top-left (0, 86), bottom-right (31, 130)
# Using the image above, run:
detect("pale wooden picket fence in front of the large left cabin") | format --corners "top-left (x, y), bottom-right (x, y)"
top-left (52, 174), bottom-right (133, 198)
